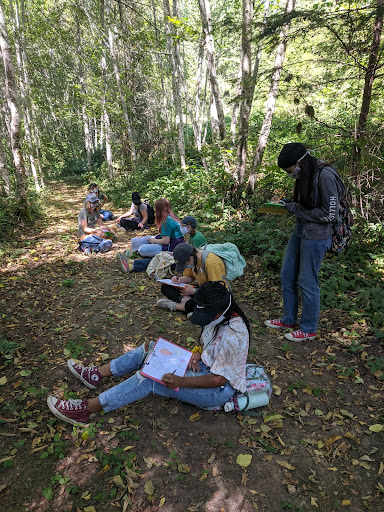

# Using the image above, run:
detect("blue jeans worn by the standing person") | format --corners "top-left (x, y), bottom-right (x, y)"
top-left (280, 221), bottom-right (332, 333)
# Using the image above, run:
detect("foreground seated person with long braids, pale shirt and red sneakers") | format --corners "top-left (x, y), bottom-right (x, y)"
top-left (47, 281), bottom-right (250, 425)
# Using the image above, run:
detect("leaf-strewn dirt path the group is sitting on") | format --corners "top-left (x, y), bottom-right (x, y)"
top-left (0, 179), bottom-right (384, 512)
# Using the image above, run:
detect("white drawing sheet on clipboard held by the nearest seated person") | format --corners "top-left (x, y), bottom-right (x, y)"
top-left (140, 338), bottom-right (192, 384)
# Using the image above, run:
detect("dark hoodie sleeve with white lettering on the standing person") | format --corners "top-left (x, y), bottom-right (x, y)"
top-left (286, 167), bottom-right (344, 223)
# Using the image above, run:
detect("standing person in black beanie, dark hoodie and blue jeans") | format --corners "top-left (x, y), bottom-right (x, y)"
top-left (264, 142), bottom-right (345, 341)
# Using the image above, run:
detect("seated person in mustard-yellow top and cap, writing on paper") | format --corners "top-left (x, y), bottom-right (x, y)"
top-left (156, 243), bottom-right (227, 313)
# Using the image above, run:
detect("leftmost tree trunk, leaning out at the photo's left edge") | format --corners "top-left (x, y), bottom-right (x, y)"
top-left (0, 2), bottom-right (30, 216)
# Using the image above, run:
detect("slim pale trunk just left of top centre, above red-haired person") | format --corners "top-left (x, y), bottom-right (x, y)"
top-left (163, 0), bottom-right (185, 167)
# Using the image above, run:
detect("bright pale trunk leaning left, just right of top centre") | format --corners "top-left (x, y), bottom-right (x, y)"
top-left (199, 0), bottom-right (226, 140)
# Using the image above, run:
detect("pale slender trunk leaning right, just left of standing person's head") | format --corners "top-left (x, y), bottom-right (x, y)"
top-left (249, 0), bottom-right (296, 191)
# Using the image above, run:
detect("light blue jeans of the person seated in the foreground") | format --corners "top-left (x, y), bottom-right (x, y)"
top-left (99, 342), bottom-right (235, 412)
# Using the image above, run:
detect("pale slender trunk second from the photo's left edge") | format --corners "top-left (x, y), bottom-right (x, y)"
top-left (10, 2), bottom-right (41, 193)
